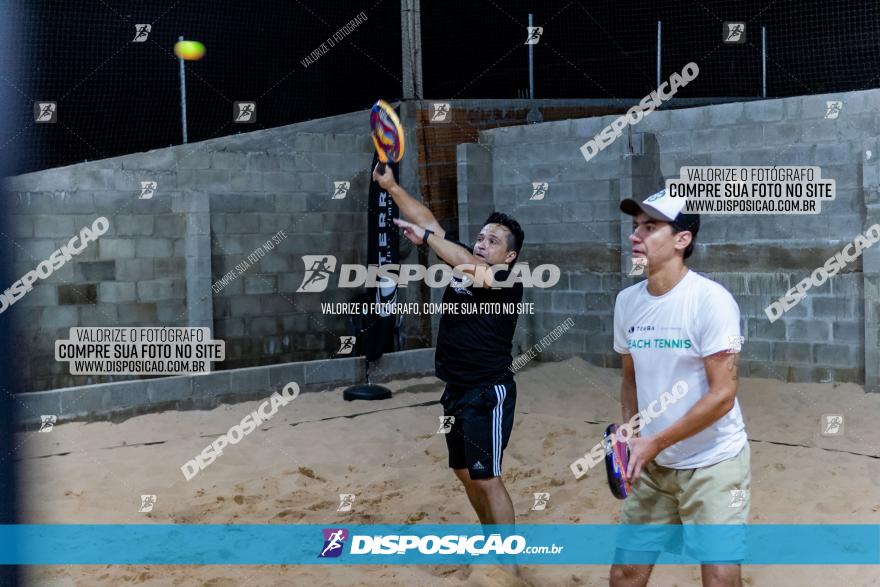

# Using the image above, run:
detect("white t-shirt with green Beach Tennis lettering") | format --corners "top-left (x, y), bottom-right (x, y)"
top-left (614, 270), bottom-right (747, 469)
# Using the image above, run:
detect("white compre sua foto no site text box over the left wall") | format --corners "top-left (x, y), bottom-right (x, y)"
top-left (55, 326), bottom-right (226, 375)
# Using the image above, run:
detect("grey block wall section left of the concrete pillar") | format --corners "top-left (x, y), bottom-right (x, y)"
top-left (4, 170), bottom-right (187, 390)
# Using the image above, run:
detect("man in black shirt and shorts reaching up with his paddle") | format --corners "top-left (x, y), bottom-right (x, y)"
top-left (373, 167), bottom-right (523, 524)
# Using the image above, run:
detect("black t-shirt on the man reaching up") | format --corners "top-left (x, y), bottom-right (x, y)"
top-left (434, 239), bottom-right (523, 387)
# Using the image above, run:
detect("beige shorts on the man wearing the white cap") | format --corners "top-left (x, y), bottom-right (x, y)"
top-left (617, 442), bottom-right (752, 562)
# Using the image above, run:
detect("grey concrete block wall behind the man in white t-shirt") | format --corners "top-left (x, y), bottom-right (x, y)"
top-left (462, 90), bottom-right (880, 391)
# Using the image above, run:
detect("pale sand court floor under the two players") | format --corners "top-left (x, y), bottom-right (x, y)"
top-left (18, 359), bottom-right (880, 586)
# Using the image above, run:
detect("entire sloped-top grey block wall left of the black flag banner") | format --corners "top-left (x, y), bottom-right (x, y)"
top-left (7, 117), bottom-right (372, 391)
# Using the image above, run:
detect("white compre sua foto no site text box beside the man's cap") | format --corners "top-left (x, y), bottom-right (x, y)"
top-left (666, 166), bottom-right (836, 214)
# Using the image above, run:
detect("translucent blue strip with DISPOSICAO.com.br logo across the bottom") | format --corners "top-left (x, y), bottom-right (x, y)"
top-left (0, 524), bottom-right (880, 565)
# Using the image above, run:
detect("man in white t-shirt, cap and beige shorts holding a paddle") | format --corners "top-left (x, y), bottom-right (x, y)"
top-left (610, 190), bottom-right (751, 587)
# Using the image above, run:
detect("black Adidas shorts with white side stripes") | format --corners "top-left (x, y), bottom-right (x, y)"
top-left (440, 381), bottom-right (516, 479)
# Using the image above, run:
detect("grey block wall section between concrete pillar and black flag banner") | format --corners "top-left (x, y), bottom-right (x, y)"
top-left (209, 134), bottom-right (372, 368)
